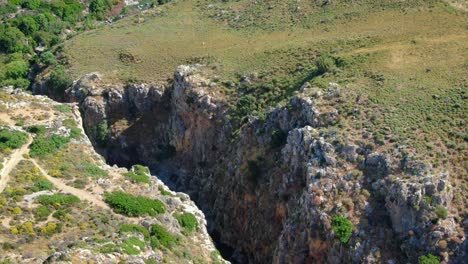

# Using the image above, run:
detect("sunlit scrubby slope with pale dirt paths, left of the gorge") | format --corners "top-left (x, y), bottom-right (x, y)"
top-left (0, 90), bottom-right (224, 263)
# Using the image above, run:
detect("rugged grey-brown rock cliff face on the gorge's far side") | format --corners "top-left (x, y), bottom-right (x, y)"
top-left (55, 65), bottom-right (466, 263)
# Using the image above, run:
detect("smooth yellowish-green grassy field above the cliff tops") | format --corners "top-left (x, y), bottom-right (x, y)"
top-left (65, 0), bottom-right (466, 81)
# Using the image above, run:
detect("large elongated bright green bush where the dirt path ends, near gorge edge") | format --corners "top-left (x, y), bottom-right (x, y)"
top-left (105, 191), bottom-right (165, 216)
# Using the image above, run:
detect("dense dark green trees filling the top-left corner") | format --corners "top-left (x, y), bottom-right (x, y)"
top-left (0, 0), bottom-right (124, 91)
